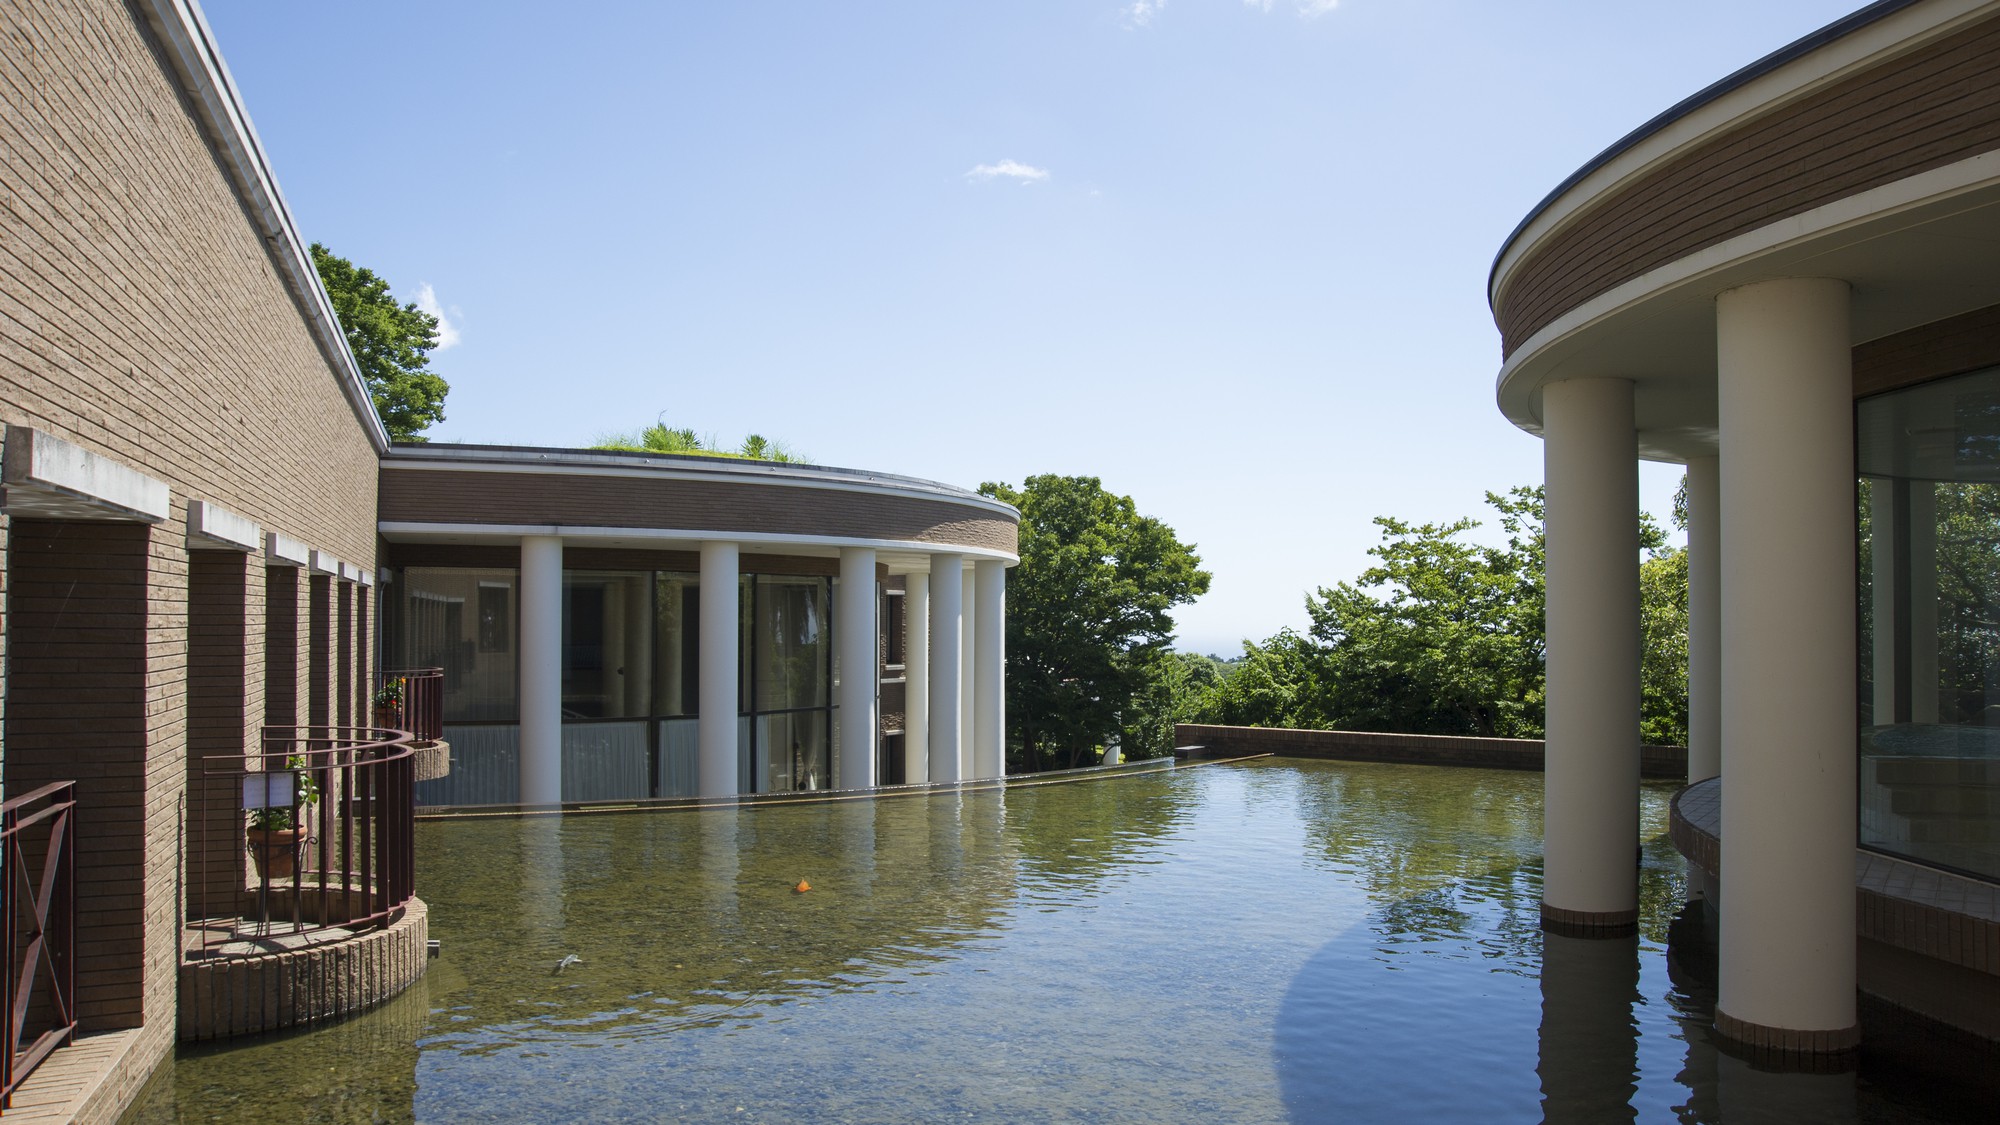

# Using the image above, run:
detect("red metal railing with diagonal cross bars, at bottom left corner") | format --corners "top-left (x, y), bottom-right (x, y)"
top-left (0, 781), bottom-right (76, 1109)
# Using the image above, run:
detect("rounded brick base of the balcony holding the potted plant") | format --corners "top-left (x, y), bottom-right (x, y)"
top-left (180, 899), bottom-right (430, 1039)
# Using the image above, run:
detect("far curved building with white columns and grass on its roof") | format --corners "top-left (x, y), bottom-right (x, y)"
top-left (380, 444), bottom-right (1020, 805)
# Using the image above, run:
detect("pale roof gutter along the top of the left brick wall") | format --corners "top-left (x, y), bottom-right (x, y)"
top-left (140, 0), bottom-right (388, 454)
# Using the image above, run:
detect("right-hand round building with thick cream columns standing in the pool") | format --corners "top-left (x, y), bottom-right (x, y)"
top-left (1488, 0), bottom-right (2000, 1055)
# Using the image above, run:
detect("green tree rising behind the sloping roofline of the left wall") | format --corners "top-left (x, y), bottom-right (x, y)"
top-left (312, 242), bottom-right (452, 442)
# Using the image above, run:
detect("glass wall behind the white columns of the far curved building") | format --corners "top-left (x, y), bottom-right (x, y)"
top-left (382, 567), bottom-right (834, 805)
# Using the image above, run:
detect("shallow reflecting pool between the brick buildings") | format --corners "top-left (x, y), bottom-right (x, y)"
top-left (128, 761), bottom-right (1996, 1123)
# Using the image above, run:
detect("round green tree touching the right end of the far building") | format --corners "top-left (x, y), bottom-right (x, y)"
top-left (980, 476), bottom-right (1208, 771)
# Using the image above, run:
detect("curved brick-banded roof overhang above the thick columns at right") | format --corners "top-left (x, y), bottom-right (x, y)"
top-left (1488, 0), bottom-right (2000, 460)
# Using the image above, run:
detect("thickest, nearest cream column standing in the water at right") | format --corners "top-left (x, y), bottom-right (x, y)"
top-left (1716, 278), bottom-right (1858, 1051)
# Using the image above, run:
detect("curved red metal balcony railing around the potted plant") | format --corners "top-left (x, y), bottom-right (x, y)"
top-left (196, 727), bottom-right (416, 957)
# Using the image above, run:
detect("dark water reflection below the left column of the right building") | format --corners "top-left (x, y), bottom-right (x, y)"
top-left (1534, 933), bottom-right (1638, 1125)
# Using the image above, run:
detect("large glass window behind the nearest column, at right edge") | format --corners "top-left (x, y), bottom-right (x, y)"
top-left (1856, 370), bottom-right (2000, 879)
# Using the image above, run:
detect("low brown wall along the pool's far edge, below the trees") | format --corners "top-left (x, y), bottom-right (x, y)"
top-left (1174, 723), bottom-right (1688, 779)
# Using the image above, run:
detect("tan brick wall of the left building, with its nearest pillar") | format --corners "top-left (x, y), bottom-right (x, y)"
top-left (0, 0), bottom-right (376, 1063)
